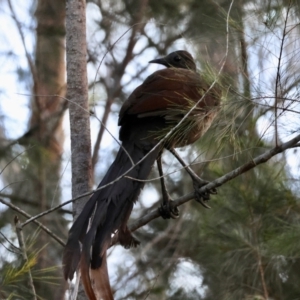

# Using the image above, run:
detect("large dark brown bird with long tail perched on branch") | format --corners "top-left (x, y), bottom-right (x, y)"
top-left (63, 50), bottom-right (221, 300)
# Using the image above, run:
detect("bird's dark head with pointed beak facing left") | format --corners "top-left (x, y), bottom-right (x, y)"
top-left (149, 50), bottom-right (196, 71)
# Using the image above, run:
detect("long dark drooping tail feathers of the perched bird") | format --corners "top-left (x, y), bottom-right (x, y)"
top-left (63, 141), bottom-right (159, 299)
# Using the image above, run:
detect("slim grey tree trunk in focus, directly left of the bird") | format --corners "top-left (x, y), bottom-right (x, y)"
top-left (66, 0), bottom-right (92, 299)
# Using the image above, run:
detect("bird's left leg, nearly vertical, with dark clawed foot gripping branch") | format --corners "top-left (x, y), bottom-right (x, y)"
top-left (156, 153), bottom-right (179, 219)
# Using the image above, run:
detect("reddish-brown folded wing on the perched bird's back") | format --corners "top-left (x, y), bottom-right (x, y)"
top-left (119, 69), bottom-right (218, 125)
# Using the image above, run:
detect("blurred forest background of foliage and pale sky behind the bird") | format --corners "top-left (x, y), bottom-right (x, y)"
top-left (0, 0), bottom-right (300, 300)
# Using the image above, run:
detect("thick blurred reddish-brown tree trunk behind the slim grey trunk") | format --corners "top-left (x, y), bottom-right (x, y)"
top-left (29, 0), bottom-right (66, 299)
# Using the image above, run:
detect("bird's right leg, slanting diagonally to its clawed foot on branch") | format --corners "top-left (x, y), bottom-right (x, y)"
top-left (169, 148), bottom-right (217, 208)
